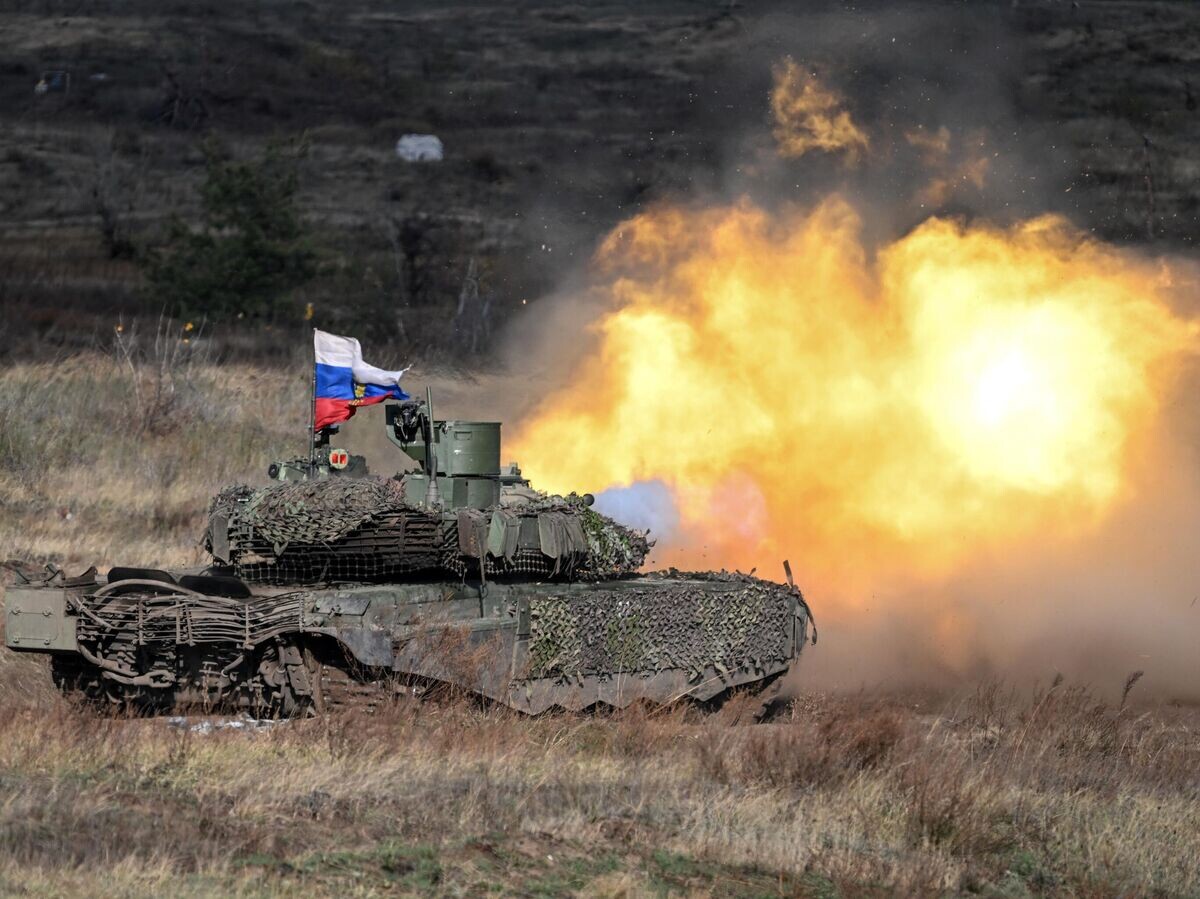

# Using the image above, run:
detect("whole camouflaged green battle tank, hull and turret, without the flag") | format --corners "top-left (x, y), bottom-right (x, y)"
top-left (6, 394), bottom-right (816, 714)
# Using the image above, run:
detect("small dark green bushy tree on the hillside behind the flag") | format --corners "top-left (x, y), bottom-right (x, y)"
top-left (145, 142), bottom-right (317, 318)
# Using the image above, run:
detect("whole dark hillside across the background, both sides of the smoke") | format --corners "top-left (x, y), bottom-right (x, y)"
top-left (0, 0), bottom-right (1200, 361)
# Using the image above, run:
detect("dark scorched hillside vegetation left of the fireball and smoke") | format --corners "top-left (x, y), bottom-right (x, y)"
top-left (0, 2), bottom-right (732, 358)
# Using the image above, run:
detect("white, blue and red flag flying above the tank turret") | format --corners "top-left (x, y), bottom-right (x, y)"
top-left (313, 330), bottom-right (408, 431)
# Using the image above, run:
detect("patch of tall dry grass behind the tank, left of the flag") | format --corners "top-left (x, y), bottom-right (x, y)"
top-left (0, 343), bottom-right (308, 569)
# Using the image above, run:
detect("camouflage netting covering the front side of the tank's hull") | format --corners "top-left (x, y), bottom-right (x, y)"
top-left (528, 573), bottom-right (803, 678)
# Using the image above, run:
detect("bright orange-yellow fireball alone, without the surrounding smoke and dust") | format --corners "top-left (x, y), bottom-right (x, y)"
top-left (516, 197), bottom-right (1195, 583)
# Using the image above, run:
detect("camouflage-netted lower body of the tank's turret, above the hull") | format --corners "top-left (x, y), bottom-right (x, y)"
top-left (205, 478), bottom-right (650, 583)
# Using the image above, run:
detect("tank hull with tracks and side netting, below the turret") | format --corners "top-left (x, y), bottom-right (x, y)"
top-left (6, 569), bottom-right (810, 714)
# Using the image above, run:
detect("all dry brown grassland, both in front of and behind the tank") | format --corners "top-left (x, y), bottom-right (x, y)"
top-left (0, 352), bottom-right (1200, 897)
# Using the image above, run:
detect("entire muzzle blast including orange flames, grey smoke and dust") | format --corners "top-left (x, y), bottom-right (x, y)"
top-left (499, 19), bottom-right (1200, 696)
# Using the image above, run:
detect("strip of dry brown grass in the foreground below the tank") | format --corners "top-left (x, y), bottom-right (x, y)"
top-left (0, 657), bottom-right (1200, 897)
